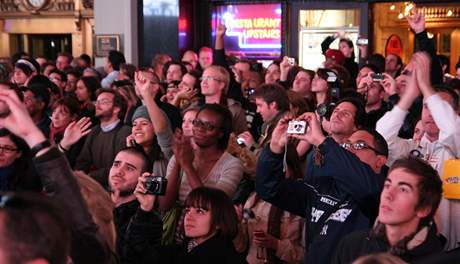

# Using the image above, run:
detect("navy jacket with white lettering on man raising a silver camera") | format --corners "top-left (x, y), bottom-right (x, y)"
top-left (256, 138), bottom-right (384, 264)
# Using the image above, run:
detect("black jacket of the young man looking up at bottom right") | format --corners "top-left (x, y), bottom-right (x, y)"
top-left (331, 223), bottom-right (442, 264)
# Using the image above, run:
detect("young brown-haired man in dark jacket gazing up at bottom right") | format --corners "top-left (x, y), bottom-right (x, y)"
top-left (332, 156), bottom-right (442, 263)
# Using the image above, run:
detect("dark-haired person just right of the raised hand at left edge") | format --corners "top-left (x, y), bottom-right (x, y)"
top-left (24, 75), bottom-right (52, 137)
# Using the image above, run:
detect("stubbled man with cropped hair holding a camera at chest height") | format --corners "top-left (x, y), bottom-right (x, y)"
top-left (109, 147), bottom-right (162, 263)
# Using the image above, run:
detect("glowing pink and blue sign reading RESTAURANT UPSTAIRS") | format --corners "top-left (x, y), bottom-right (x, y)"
top-left (212, 4), bottom-right (282, 58)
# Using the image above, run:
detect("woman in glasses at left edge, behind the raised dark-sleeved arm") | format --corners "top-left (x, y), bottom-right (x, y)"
top-left (0, 129), bottom-right (42, 192)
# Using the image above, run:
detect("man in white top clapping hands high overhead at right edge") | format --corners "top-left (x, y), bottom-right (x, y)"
top-left (377, 52), bottom-right (460, 248)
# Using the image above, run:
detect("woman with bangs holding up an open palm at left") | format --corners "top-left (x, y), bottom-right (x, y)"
top-left (49, 96), bottom-right (91, 168)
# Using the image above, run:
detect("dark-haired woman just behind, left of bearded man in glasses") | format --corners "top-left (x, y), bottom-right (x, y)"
top-left (75, 76), bottom-right (101, 124)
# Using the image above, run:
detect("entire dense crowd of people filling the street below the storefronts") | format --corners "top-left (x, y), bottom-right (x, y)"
top-left (0, 7), bottom-right (460, 264)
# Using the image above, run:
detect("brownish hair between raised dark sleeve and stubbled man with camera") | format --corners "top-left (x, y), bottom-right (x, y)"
top-left (74, 171), bottom-right (116, 252)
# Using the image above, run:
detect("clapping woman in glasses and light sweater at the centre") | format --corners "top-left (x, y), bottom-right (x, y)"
top-left (159, 104), bottom-right (243, 245)
